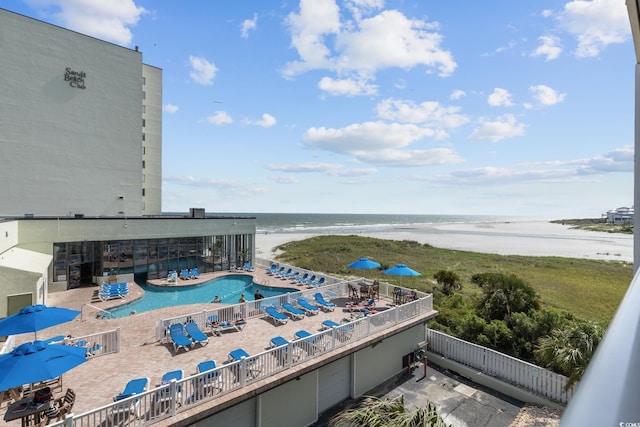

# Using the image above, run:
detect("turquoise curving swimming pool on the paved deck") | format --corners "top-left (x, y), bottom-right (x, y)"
top-left (109, 274), bottom-right (299, 317)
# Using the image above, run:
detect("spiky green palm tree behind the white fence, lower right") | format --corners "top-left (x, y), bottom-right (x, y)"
top-left (534, 322), bottom-right (604, 389)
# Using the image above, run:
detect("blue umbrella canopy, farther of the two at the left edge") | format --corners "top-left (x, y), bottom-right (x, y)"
top-left (0, 304), bottom-right (80, 337)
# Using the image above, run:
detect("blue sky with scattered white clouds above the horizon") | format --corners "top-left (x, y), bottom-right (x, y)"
top-left (0, 0), bottom-right (636, 219)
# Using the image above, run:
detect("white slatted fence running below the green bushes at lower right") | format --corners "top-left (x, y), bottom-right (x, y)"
top-left (427, 329), bottom-right (574, 404)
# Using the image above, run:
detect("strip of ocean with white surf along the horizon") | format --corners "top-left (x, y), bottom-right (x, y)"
top-left (207, 212), bottom-right (531, 234)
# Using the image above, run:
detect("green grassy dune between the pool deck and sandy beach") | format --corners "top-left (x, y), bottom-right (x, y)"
top-left (278, 236), bottom-right (633, 322)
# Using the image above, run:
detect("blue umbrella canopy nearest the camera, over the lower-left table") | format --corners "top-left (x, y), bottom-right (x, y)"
top-left (0, 341), bottom-right (87, 390)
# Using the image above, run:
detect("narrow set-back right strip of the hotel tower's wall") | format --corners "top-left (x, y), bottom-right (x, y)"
top-left (141, 65), bottom-right (162, 215)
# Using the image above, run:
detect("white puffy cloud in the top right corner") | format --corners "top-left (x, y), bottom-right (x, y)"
top-left (558, 0), bottom-right (630, 57)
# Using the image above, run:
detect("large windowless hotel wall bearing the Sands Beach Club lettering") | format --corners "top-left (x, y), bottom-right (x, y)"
top-left (0, 9), bottom-right (142, 216)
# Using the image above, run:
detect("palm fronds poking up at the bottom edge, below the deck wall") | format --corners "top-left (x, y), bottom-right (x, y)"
top-left (329, 395), bottom-right (451, 427)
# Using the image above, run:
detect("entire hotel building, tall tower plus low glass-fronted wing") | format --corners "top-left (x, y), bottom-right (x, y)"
top-left (0, 9), bottom-right (255, 318)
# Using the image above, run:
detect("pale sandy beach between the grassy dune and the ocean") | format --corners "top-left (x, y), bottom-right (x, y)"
top-left (256, 221), bottom-right (633, 262)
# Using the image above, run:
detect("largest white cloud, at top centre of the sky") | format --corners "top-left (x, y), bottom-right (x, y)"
top-left (283, 0), bottom-right (457, 84)
